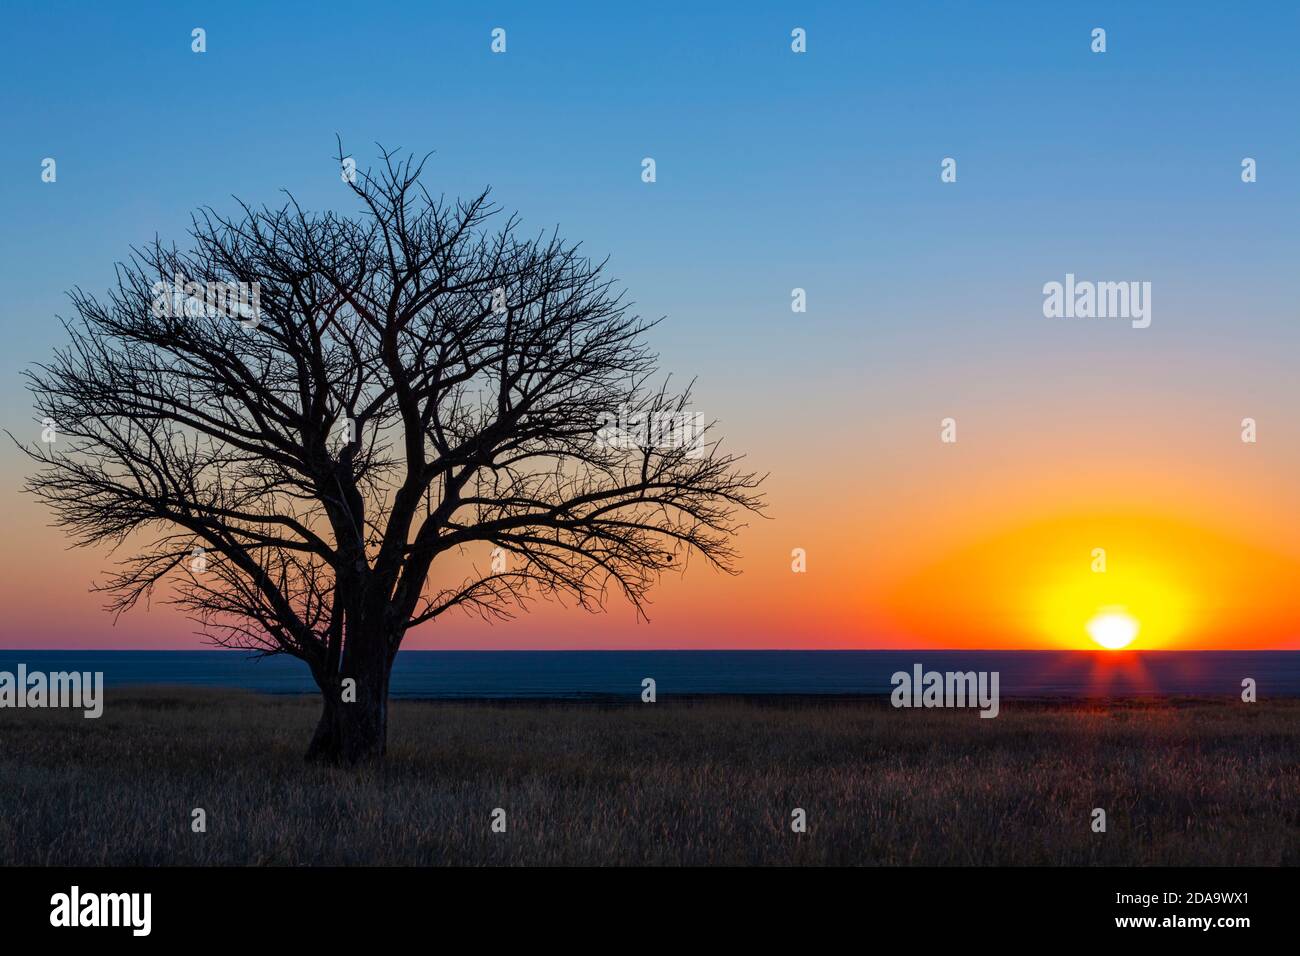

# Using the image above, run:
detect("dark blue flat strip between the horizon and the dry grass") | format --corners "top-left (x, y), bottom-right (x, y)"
top-left (0, 650), bottom-right (1300, 698)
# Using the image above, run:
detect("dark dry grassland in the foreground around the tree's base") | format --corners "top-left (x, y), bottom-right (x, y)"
top-left (0, 688), bottom-right (1300, 865)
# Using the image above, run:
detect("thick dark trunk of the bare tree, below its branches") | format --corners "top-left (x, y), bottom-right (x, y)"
top-left (307, 633), bottom-right (393, 766)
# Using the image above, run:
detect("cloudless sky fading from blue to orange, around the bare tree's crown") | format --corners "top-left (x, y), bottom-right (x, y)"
top-left (0, 1), bottom-right (1300, 648)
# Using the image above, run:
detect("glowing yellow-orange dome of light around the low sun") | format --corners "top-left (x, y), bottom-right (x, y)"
top-left (881, 511), bottom-right (1300, 650)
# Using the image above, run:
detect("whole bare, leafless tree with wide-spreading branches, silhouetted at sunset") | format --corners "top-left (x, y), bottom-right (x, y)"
top-left (23, 148), bottom-right (762, 763)
